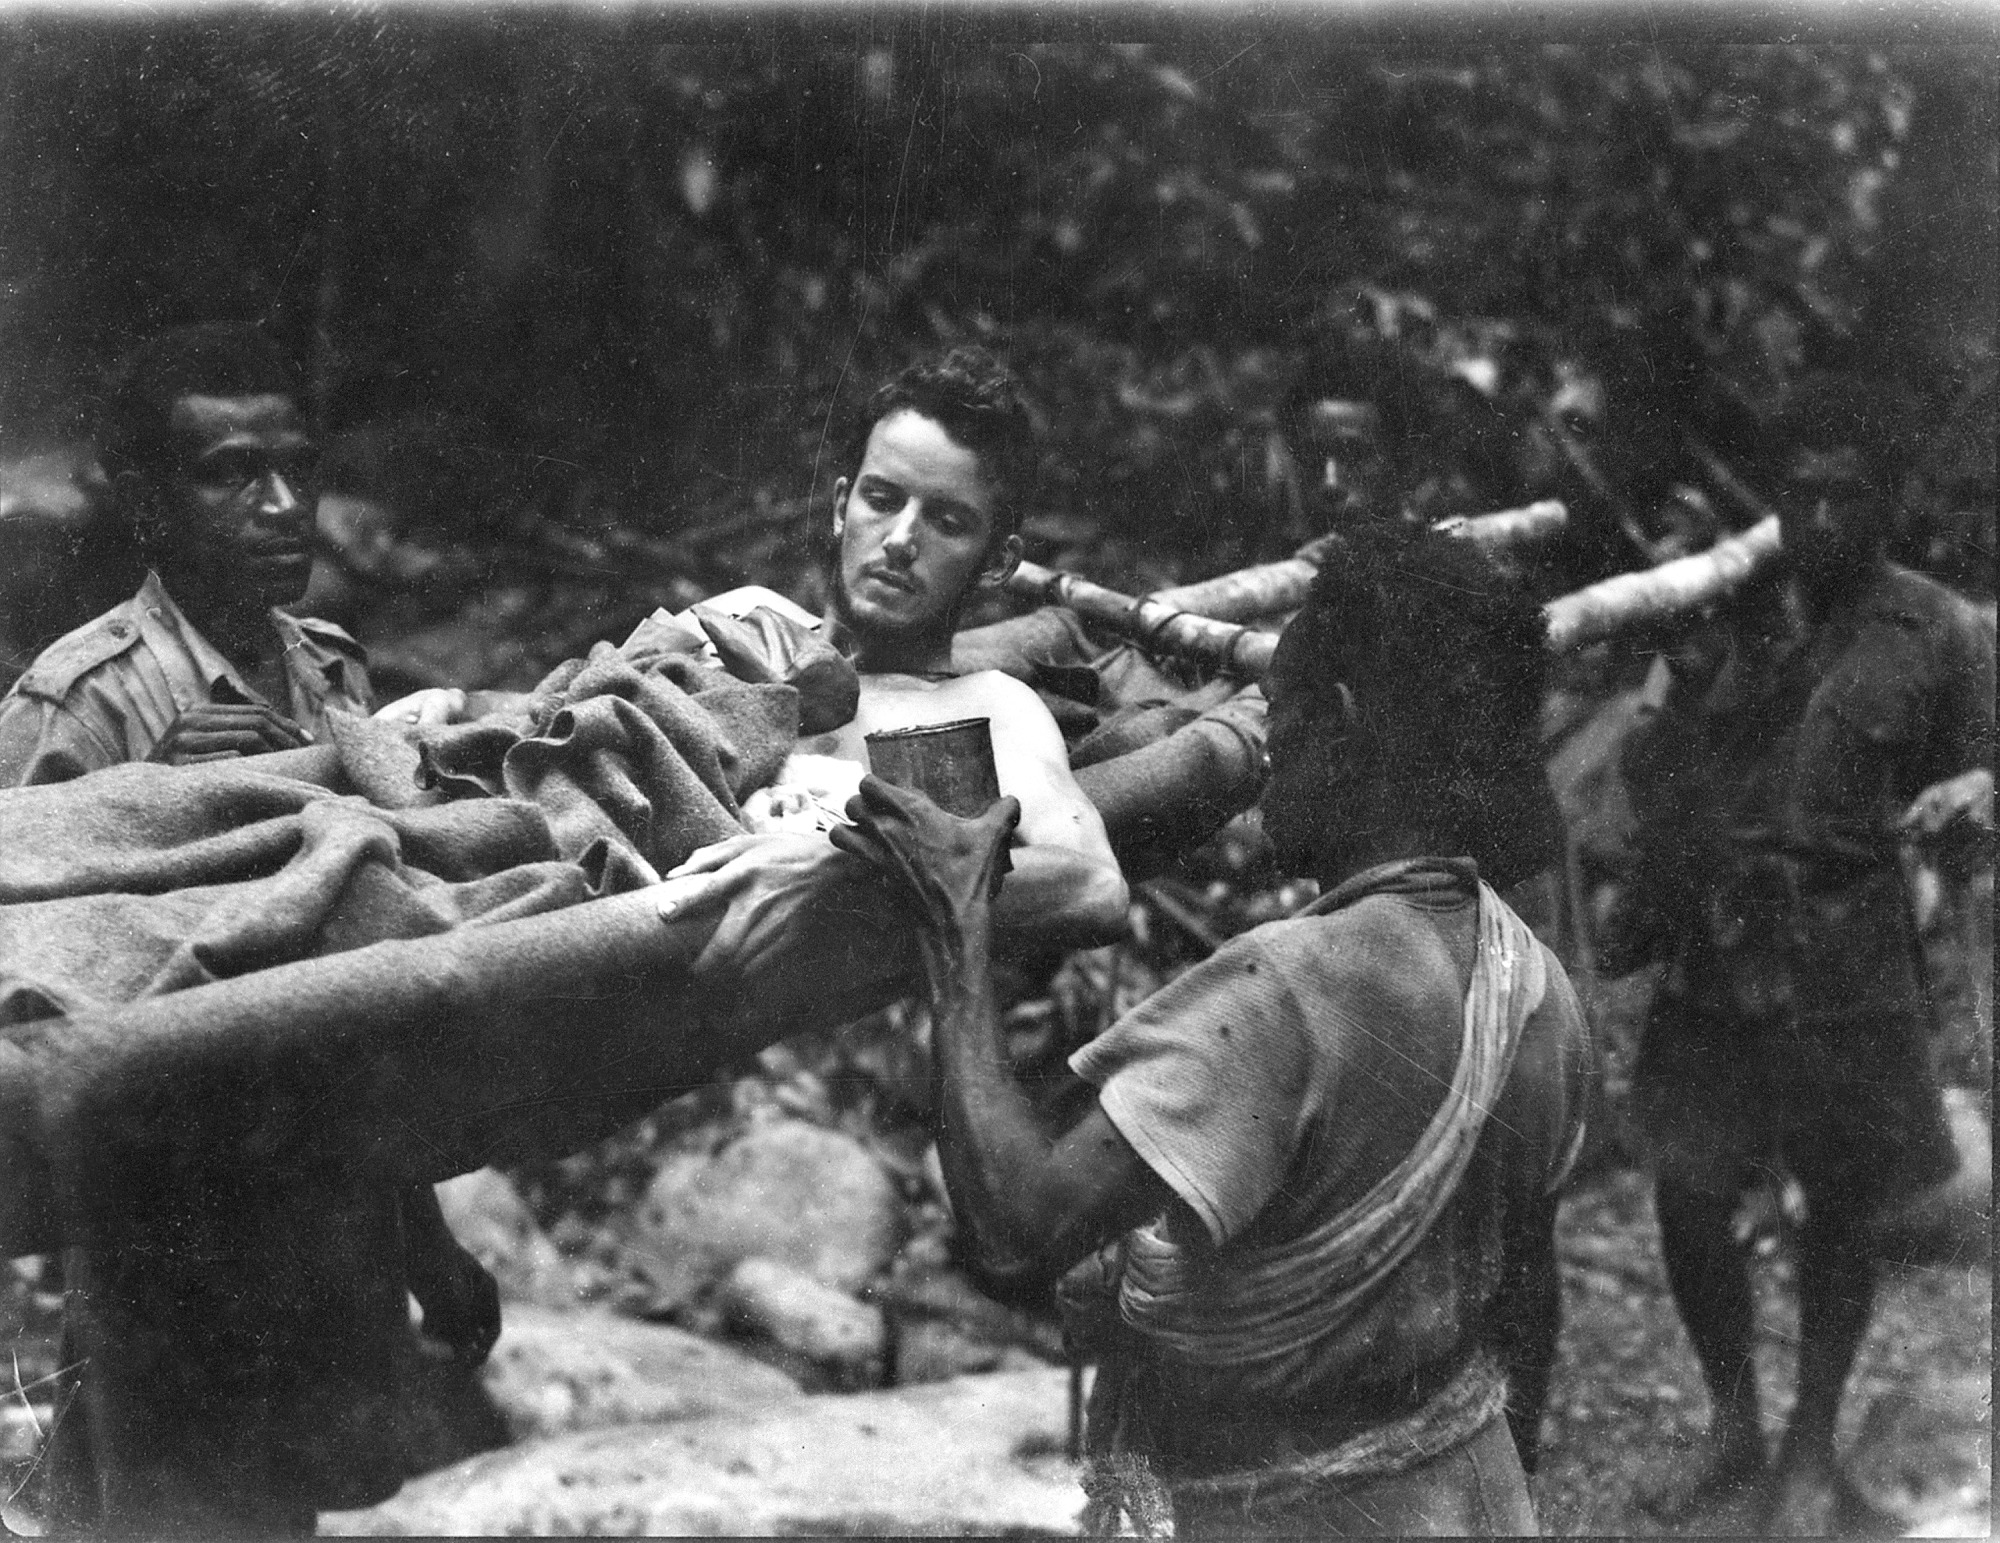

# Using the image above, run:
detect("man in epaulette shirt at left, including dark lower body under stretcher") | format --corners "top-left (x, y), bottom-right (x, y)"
top-left (0, 324), bottom-right (500, 1537)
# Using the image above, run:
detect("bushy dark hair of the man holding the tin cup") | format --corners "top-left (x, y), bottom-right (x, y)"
top-left (1288, 522), bottom-right (1558, 887)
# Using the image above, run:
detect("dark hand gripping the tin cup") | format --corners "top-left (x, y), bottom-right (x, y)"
top-left (828, 775), bottom-right (1020, 929)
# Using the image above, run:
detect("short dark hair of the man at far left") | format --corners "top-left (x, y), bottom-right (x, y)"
top-left (98, 322), bottom-right (298, 478)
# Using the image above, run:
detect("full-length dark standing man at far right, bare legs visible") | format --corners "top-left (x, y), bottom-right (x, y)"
top-left (1620, 382), bottom-right (1994, 1535)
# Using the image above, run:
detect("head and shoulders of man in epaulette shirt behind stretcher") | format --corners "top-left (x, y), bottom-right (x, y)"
top-left (0, 324), bottom-right (370, 787)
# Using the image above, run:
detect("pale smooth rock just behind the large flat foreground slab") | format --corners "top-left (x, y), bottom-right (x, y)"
top-left (484, 1305), bottom-right (804, 1439)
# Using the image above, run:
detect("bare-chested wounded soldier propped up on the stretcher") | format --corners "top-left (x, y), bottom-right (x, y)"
top-left (380, 350), bottom-right (1232, 947)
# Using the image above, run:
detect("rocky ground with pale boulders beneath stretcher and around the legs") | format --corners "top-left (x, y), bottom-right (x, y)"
top-left (0, 981), bottom-right (1992, 1537)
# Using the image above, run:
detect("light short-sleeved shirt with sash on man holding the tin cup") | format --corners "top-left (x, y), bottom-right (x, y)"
top-left (1072, 859), bottom-right (1590, 1509)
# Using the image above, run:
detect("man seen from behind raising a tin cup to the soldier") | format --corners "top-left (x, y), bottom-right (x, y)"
top-left (834, 532), bottom-right (1592, 1537)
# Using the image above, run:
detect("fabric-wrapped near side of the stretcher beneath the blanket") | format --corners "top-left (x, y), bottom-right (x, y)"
top-left (0, 865), bottom-right (912, 1255)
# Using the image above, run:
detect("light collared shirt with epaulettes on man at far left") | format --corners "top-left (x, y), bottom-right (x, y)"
top-left (0, 574), bottom-right (370, 787)
